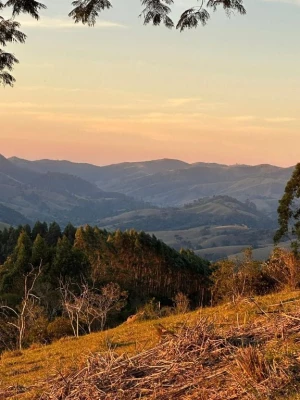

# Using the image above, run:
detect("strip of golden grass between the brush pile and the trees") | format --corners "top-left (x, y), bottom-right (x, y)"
top-left (0, 291), bottom-right (300, 400)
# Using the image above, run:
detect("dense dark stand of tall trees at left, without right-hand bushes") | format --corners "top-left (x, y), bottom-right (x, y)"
top-left (0, 222), bottom-right (211, 348)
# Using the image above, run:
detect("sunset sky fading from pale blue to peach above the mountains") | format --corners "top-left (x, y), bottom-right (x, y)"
top-left (0, 0), bottom-right (300, 166)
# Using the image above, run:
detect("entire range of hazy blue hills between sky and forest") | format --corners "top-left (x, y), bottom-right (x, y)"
top-left (0, 156), bottom-right (293, 258)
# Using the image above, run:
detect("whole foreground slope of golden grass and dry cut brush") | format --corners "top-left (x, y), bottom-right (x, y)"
top-left (0, 291), bottom-right (300, 400)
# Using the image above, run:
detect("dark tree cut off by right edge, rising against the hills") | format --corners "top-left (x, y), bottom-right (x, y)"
top-left (274, 163), bottom-right (300, 253)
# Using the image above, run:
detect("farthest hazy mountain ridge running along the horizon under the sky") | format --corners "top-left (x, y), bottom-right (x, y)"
top-left (11, 158), bottom-right (293, 217)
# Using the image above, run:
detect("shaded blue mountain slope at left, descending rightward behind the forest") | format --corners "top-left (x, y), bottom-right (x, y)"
top-left (0, 156), bottom-right (145, 225)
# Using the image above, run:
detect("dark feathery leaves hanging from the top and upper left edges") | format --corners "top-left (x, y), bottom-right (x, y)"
top-left (0, 0), bottom-right (246, 86)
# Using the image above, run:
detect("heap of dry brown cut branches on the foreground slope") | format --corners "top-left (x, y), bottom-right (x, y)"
top-left (36, 312), bottom-right (300, 400)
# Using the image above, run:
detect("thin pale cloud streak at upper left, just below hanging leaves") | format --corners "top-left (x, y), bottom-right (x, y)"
top-left (20, 17), bottom-right (126, 29)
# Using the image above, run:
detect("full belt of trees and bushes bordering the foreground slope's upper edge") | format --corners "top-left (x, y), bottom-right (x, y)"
top-left (0, 221), bottom-right (300, 352)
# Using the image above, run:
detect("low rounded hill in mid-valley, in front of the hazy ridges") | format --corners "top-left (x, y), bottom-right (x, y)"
top-left (98, 196), bottom-right (275, 232)
